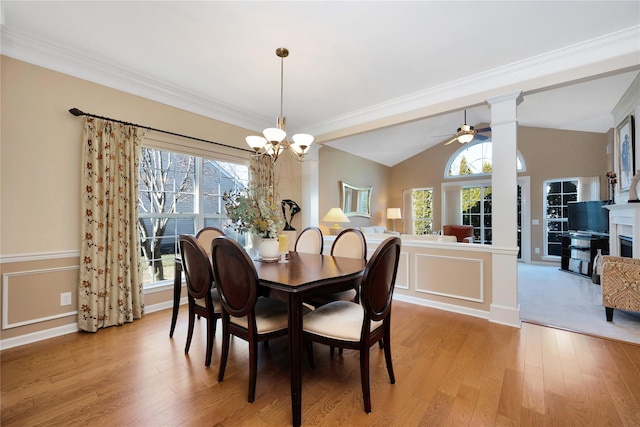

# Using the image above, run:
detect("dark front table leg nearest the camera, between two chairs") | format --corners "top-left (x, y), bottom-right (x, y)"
top-left (289, 292), bottom-right (303, 427)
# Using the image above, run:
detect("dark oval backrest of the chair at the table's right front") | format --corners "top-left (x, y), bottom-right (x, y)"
top-left (360, 236), bottom-right (401, 321)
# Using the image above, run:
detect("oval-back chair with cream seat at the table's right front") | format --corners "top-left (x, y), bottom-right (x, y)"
top-left (303, 237), bottom-right (400, 413)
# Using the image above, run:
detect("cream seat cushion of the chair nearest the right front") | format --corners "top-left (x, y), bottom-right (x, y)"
top-left (302, 301), bottom-right (382, 342)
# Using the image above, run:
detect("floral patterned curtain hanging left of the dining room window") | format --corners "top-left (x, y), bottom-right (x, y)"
top-left (78, 117), bottom-right (144, 332)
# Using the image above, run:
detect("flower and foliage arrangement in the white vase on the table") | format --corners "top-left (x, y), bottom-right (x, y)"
top-left (222, 190), bottom-right (284, 238)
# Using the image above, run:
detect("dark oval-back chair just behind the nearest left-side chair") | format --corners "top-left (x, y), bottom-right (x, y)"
top-left (178, 234), bottom-right (222, 366)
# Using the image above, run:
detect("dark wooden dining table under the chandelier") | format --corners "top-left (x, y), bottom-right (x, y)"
top-left (253, 252), bottom-right (366, 426)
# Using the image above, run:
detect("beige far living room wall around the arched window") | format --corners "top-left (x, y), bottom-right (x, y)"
top-left (388, 127), bottom-right (613, 261)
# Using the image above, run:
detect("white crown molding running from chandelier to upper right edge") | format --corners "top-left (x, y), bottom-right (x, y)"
top-left (301, 25), bottom-right (640, 139)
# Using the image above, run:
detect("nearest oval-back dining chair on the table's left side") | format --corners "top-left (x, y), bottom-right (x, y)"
top-left (211, 237), bottom-right (289, 402)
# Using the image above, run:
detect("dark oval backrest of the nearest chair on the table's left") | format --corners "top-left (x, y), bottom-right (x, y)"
top-left (211, 236), bottom-right (258, 317)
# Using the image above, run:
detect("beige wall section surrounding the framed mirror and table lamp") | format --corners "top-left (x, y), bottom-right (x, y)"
top-left (318, 146), bottom-right (388, 233)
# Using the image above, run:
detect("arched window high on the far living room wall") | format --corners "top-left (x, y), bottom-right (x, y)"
top-left (444, 141), bottom-right (525, 178)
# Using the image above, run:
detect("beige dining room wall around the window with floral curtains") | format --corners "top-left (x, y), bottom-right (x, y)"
top-left (0, 56), bottom-right (304, 340)
